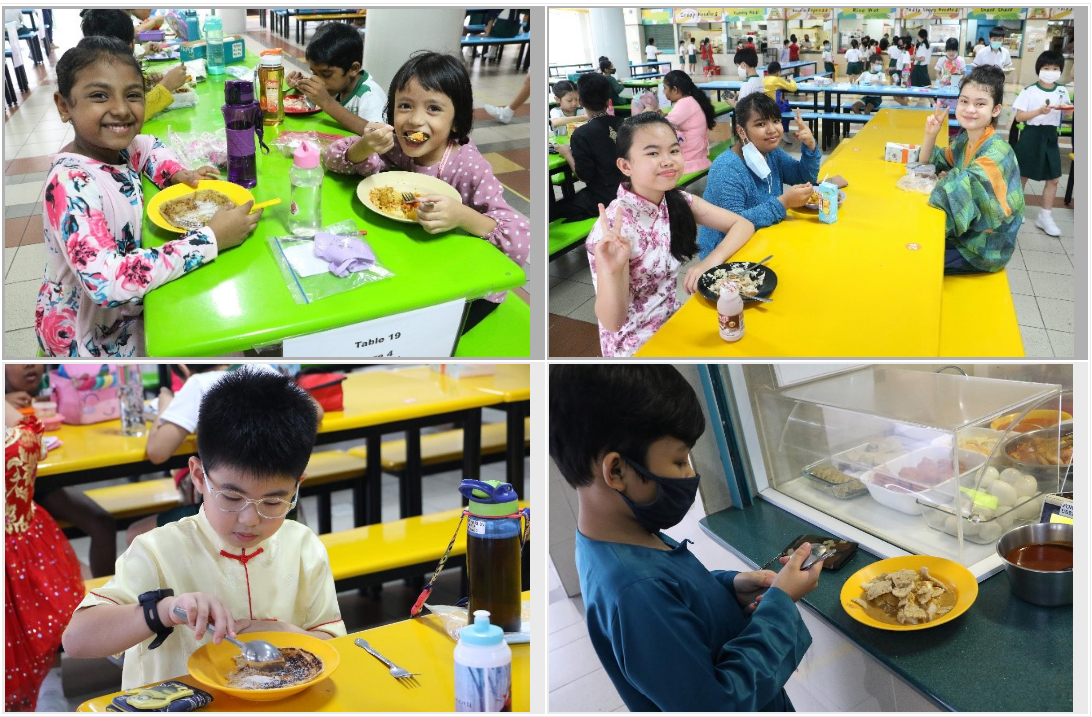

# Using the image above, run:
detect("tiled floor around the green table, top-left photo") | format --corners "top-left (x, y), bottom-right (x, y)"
top-left (3, 10), bottom-right (532, 358)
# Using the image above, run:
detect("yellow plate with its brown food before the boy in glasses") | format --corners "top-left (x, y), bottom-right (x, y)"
top-left (186, 632), bottom-right (341, 702)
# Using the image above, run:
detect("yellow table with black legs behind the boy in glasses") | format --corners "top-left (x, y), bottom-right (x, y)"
top-left (38, 368), bottom-right (506, 526)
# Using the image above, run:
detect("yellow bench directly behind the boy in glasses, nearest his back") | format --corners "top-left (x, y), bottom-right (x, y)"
top-left (84, 501), bottom-right (530, 593)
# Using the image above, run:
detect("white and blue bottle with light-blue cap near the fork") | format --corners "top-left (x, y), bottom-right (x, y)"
top-left (454, 610), bottom-right (512, 712)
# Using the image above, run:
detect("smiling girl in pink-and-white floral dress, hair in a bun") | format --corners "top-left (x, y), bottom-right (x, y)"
top-left (34, 37), bottom-right (261, 357)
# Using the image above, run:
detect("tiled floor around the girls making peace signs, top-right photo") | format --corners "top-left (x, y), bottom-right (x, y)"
top-left (549, 117), bottom-right (1079, 357)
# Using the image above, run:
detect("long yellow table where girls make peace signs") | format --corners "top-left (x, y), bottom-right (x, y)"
top-left (637, 145), bottom-right (945, 357)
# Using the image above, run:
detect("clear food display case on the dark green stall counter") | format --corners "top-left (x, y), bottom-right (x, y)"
top-left (750, 366), bottom-right (1072, 581)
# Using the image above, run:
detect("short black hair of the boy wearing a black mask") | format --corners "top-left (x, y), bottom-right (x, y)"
top-left (549, 366), bottom-right (707, 488)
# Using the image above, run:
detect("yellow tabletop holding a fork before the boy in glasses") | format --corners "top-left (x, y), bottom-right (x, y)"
top-left (79, 593), bottom-right (531, 713)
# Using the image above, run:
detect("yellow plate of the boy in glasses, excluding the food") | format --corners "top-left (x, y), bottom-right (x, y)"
top-left (186, 632), bottom-right (341, 702)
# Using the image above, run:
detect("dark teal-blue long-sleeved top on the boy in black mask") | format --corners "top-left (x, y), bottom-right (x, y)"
top-left (577, 530), bottom-right (811, 713)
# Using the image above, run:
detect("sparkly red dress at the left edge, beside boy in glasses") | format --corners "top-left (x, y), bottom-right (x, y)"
top-left (3, 418), bottom-right (84, 712)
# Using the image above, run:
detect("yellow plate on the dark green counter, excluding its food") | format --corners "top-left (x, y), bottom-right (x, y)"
top-left (840, 555), bottom-right (978, 632)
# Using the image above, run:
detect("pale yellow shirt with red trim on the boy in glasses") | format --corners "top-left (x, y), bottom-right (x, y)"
top-left (76, 505), bottom-right (345, 690)
